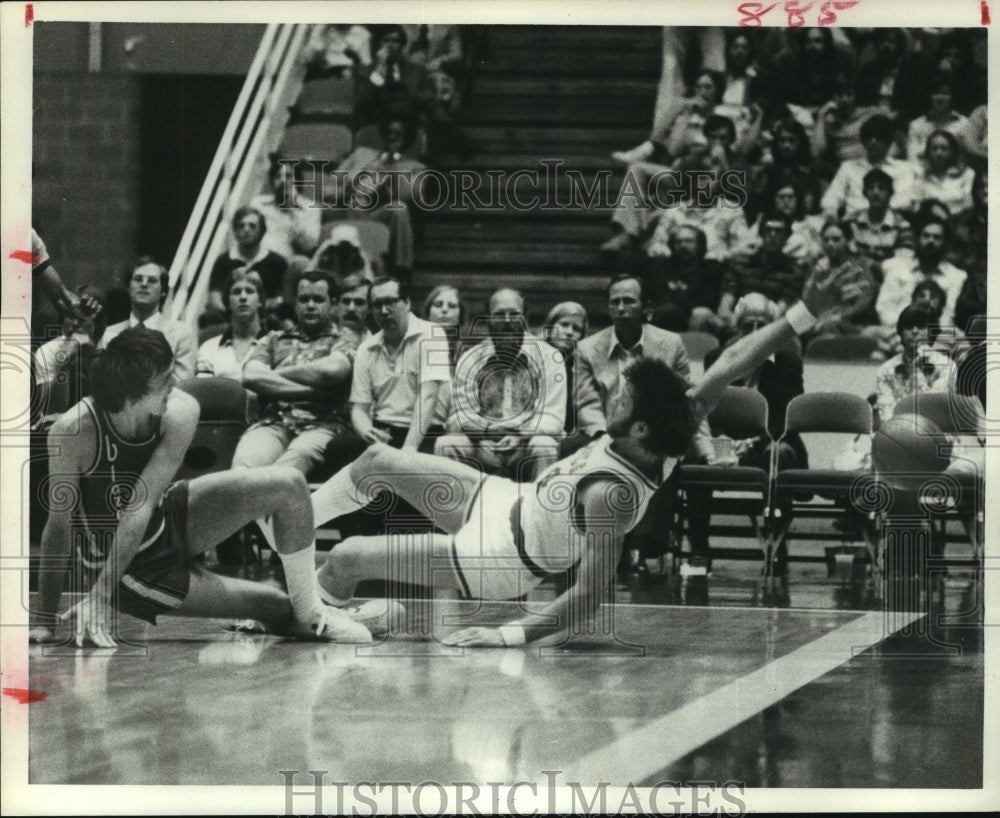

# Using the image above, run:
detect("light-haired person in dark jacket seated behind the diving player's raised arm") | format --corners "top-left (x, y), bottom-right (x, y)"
top-left (687, 293), bottom-right (809, 571)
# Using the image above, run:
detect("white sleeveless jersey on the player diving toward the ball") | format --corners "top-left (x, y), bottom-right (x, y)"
top-left (512, 435), bottom-right (677, 573)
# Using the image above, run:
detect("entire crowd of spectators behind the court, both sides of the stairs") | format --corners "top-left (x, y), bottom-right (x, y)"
top-left (29, 25), bottom-right (988, 572)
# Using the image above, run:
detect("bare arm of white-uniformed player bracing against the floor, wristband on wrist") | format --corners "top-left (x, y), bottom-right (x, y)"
top-left (443, 481), bottom-right (632, 647)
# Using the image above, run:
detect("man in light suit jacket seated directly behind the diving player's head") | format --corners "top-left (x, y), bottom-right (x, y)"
top-left (578, 273), bottom-right (711, 571)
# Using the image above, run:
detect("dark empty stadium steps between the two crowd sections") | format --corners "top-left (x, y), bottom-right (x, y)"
top-left (415, 26), bottom-right (660, 324)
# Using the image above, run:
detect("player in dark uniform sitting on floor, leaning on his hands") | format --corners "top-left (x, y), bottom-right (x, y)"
top-left (30, 327), bottom-right (371, 647)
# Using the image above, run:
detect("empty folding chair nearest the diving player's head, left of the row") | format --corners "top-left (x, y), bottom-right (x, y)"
top-left (674, 386), bottom-right (772, 572)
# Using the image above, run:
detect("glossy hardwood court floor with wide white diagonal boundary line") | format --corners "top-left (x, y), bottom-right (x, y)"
top-left (29, 576), bottom-right (984, 788)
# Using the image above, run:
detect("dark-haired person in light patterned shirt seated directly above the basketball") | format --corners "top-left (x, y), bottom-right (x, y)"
top-left (875, 304), bottom-right (951, 421)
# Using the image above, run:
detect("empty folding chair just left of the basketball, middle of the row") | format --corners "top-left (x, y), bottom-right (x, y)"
top-left (764, 392), bottom-right (880, 586)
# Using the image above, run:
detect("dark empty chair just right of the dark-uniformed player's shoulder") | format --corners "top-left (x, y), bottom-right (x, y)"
top-left (177, 378), bottom-right (257, 478)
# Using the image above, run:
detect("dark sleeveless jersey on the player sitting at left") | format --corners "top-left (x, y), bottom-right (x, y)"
top-left (75, 398), bottom-right (163, 569)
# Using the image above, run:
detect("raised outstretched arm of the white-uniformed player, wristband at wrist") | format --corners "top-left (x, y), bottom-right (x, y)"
top-left (688, 262), bottom-right (867, 414)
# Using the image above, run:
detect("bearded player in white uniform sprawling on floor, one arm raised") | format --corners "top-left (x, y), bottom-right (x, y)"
top-left (313, 264), bottom-right (864, 647)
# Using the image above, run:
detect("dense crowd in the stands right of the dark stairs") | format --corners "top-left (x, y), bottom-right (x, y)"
top-left (602, 28), bottom-right (987, 360)
